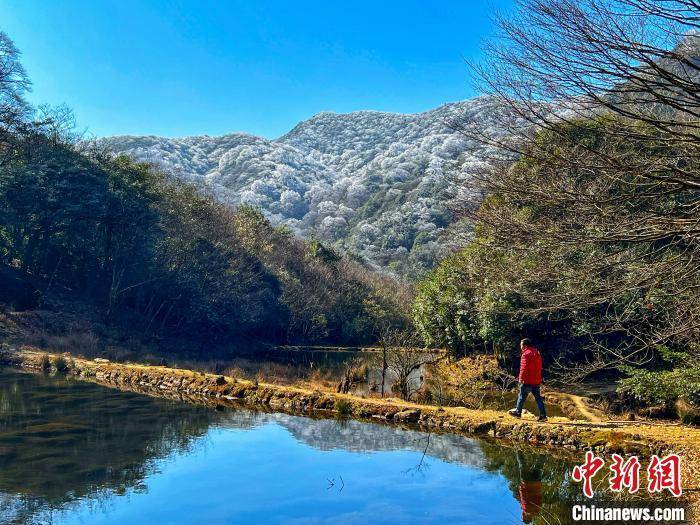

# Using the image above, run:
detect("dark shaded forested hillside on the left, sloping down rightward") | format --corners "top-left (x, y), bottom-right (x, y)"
top-left (0, 33), bottom-right (407, 344)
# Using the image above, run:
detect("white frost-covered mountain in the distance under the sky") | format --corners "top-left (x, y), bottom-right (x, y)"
top-left (103, 97), bottom-right (499, 274)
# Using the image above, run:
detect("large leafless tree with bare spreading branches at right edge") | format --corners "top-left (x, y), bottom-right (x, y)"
top-left (453, 0), bottom-right (700, 373)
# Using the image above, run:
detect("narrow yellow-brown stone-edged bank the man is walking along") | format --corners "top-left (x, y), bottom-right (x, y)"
top-left (0, 345), bottom-right (700, 512)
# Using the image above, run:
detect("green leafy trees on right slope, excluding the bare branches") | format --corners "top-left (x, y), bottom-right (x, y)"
top-left (414, 119), bottom-right (698, 376)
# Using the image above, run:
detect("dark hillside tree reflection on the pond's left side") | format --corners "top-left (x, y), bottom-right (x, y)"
top-left (0, 372), bottom-right (219, 523)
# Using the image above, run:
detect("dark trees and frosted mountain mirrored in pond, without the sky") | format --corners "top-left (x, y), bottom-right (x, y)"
top-left (0, 371), bottom-right (600, 523)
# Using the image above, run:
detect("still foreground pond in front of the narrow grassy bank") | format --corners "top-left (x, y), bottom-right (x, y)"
top-left (0, 370), bottom-right (580, 525)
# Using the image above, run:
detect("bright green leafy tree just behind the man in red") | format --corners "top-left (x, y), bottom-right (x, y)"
top-left (413, 221), bottom-right (576, 369)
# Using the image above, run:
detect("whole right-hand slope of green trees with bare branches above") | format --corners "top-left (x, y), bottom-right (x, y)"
top-left (414, 0), bottom-right (700, 416)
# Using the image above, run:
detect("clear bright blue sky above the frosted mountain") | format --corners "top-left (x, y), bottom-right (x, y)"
top-left (0, 0), bottom-right (511, 138)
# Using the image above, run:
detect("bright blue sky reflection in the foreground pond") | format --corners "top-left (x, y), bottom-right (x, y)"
top-left (47, 423), bottom-right (520, 525)
